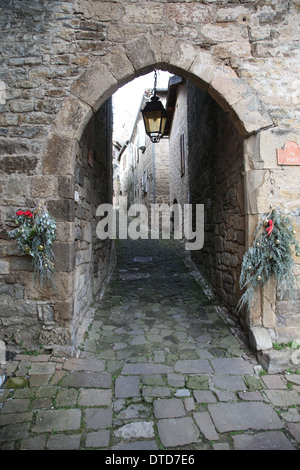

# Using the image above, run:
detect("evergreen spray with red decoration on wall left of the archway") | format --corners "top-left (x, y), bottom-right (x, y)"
top-left (9, 206), bottom-right (56, 286)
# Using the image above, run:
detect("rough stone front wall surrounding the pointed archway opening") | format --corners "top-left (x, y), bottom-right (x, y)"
top-left (0, 0), bottom-right (300, 360)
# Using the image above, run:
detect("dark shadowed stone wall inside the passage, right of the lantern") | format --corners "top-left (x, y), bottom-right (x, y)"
top-left (187, 82), bottom-right (245, 320)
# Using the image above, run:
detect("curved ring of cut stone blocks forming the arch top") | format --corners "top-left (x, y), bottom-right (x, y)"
top-left (45, 38), bottom-right (274, 175)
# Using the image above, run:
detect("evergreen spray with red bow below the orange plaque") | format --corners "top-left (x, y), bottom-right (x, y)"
top-left (238, 209), bottom-right (300, 310)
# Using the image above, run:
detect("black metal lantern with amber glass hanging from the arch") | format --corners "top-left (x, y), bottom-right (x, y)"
top-left (142, 70), bottom-right (167, 143)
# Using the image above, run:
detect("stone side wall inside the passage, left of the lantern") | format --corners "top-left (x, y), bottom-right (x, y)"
top-left (73, 99), bottom-right (112, 344)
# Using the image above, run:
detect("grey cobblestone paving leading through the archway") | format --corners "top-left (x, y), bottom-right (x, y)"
top-left (0, 240), bottom-right (300, 451)
